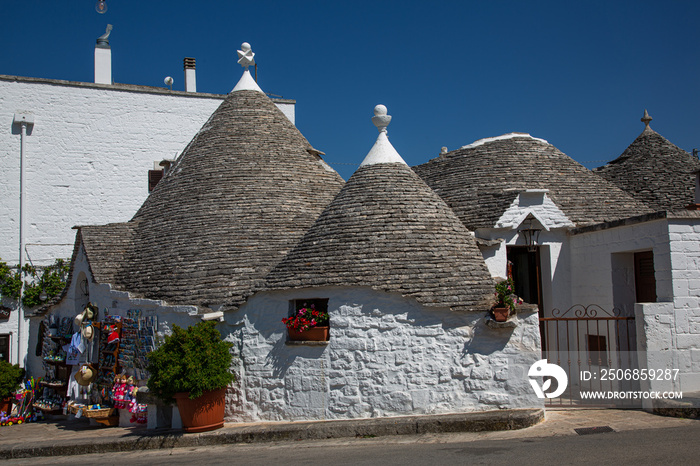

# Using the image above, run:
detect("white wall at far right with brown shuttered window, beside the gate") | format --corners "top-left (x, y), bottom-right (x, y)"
top-left (571, 219), bottom-right (700, 396)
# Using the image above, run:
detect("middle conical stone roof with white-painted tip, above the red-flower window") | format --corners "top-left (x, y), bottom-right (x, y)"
top-left (266, 105), bottom-right (494, 310)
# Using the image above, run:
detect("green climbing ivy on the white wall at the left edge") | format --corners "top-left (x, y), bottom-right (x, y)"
top-left (0, 259), bottom-right (69, 307)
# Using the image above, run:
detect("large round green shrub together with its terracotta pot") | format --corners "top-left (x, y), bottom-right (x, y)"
top-left (148, 322), bottom-right (235, 432)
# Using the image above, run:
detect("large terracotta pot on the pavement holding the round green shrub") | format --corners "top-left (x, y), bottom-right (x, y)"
top-left (175, 387), bottom-right (226, 432)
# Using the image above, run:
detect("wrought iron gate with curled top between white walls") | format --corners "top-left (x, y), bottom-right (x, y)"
top-left (540, 304), bottom-right (641, 408)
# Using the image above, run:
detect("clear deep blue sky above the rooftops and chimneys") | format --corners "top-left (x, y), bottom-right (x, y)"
top-left (0, 0), bottom-right (700, 179)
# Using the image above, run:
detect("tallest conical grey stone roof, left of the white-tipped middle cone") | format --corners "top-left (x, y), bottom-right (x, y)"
top-left (71, 51), bottom-right (344, 310)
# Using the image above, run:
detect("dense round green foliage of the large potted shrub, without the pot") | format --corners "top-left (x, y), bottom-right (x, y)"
top-left (148, 322), bottom-right (235, 403)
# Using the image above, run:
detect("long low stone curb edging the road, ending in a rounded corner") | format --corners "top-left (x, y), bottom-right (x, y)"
top-left (0, 409), bottom-right (544, 459)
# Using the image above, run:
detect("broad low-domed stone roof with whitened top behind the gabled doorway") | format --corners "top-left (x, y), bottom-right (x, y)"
top-left (413, 133), bottom-right (649, 230)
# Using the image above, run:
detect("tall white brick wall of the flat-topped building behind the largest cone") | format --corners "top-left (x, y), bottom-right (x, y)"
top-left (0, 75), bottom-right (294, 265)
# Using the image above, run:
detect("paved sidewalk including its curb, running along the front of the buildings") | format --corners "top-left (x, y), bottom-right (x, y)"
top-left (0, 409), bottom-right (700, 459)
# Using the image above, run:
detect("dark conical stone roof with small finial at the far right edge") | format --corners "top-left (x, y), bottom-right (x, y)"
top-left (593, 116), bottom-right (700, 210)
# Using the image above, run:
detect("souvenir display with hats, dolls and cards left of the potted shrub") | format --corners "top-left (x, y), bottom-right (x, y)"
top-left (29, 304), bottom-right (157, 426)
